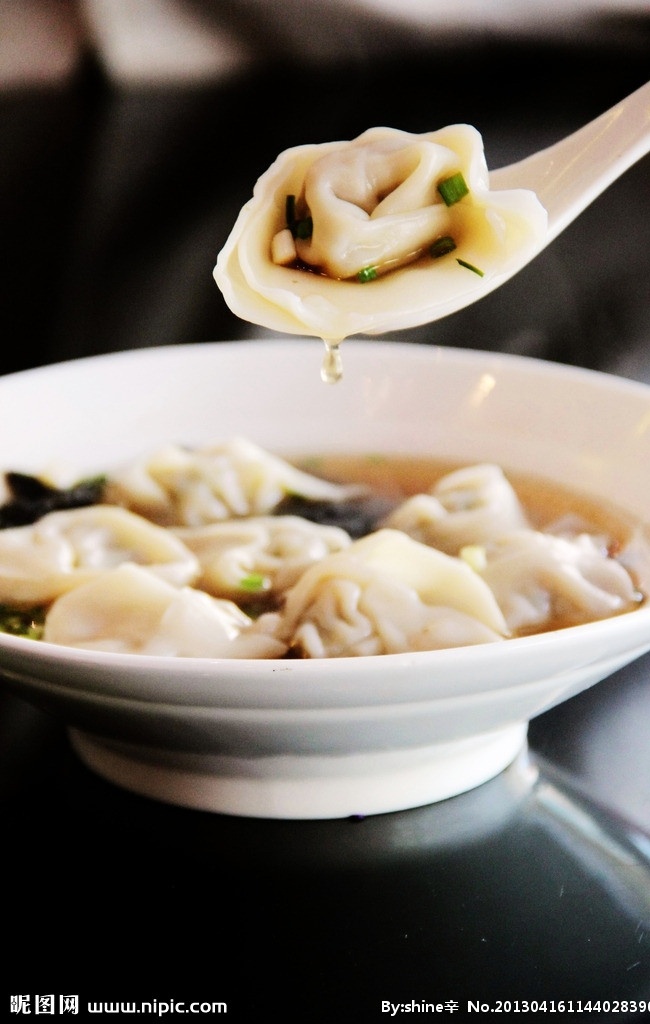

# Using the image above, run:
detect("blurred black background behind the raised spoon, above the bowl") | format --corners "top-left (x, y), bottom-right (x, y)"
top-left (0, 29), bottom-right (650, 379)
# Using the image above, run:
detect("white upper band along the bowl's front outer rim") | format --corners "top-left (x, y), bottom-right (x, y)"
top-left (0, 602), bottom-right (650, 710)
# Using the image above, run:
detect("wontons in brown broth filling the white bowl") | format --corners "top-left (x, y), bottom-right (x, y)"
top-left (0, 438), bottom-right (650, 658)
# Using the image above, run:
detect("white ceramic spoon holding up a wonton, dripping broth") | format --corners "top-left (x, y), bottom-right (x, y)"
top-left (215, 82), bottom-right (650, 383)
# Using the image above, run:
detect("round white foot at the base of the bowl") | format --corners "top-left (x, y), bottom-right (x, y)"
top-left (70, 724), bottom-right (527, 819)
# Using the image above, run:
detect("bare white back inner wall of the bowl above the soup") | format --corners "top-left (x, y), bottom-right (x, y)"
top-left (0, 339), bottom-right (650, 516)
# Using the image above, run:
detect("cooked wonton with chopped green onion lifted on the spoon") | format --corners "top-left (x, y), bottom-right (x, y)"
top-left (214, 124), bottom-right (547, 343)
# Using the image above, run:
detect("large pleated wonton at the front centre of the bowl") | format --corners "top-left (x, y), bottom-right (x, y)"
top-left (270, 529), bottom-right (508, 657)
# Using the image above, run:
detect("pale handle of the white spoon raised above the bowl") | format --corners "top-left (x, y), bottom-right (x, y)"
top-left (490, 82), bottom-right (650, 242)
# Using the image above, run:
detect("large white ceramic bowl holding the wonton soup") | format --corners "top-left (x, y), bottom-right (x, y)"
top-left (0, 339), bottom-right (650, 818)
